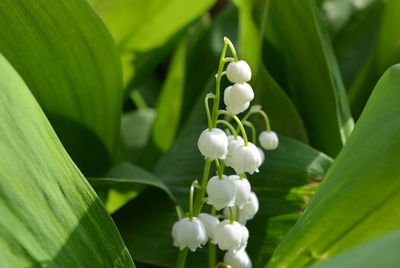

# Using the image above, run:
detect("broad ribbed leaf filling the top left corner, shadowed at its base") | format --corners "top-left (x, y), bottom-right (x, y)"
top-left (0, 0), bottom-right (122, 175)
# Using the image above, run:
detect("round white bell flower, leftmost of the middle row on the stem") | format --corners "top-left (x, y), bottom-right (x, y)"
top-left (197, 128), bottom-right (228, 160)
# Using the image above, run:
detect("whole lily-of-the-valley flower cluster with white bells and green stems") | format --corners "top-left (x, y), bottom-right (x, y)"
top-left (172, 38), bottom-right (279, 268)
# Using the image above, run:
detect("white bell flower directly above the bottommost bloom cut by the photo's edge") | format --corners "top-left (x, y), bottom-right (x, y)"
top-left (212, 220), bottom-right (243, 250)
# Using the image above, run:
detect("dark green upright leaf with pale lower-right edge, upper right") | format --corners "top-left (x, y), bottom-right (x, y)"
top-left (263, 0), bottom-right (353, 156)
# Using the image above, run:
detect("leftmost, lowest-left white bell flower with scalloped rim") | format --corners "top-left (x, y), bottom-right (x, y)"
top-left (172, 218), bottom-right (208, 251)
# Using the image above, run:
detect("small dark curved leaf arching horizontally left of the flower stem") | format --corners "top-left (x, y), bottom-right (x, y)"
top-left (89, 163), bottom-right (175, 201)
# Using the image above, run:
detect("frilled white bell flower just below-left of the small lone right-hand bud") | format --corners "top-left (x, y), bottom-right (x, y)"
top-left (232, 142), bottom-right (261, 174)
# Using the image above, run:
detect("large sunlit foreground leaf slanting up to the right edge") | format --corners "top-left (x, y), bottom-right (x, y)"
top-left (268, 65), bottom-right (400, 267)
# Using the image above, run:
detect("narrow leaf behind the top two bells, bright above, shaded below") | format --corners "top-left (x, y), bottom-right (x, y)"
top-left (236, 0), bottom-right (308, 142)
